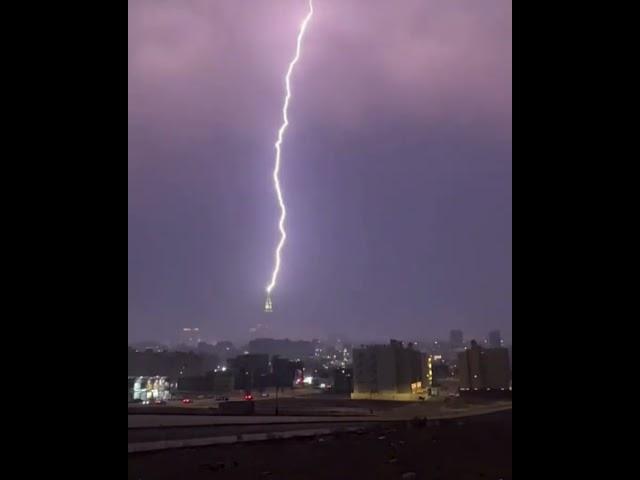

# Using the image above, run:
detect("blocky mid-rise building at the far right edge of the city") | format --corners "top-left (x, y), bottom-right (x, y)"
top-left (458, 341), bottom-right (511, 390)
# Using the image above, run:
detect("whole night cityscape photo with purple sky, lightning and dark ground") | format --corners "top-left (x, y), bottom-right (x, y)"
top-left (128, 0), bottom-right (513, 480)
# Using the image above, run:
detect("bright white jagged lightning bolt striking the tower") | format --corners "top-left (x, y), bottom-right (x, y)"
top-left (265, 0), bottom-right (313, 304)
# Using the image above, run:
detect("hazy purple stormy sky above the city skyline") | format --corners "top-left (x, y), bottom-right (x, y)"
top-left (128, 0), bottom-right (512, 341)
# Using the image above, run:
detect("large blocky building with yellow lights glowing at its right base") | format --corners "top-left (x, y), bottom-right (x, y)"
top-left (351, 340), bottom-right (427, 400)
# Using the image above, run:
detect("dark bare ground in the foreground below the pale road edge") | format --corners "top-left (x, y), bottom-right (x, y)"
top-left (129, 411), bottom-right (513, 480)
